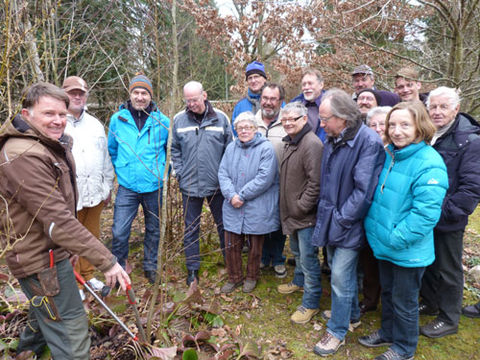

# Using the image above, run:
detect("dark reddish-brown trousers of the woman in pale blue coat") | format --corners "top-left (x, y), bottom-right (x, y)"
top-left (225, 231), bottom-right (264, 284)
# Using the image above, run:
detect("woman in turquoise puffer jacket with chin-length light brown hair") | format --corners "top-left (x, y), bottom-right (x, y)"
top-left (358, 101), bottom-right (448, 360)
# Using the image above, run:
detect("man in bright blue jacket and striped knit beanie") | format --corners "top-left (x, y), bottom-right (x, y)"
top-left (108, 75), bottom-right (170, 283)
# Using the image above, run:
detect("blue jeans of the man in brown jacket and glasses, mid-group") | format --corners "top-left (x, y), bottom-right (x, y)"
top-left (290, 226), bottom-right (322, 309)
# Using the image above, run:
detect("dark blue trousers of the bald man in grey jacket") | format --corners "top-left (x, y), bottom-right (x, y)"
top-left (182, 190), bottom-right (225, 270)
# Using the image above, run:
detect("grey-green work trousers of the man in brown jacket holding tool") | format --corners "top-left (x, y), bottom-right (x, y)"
top-left (17, 260), bottom-right (90, 360)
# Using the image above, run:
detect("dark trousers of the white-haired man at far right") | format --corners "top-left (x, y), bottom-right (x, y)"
top-left (420, 230), bottom-right (463, 325)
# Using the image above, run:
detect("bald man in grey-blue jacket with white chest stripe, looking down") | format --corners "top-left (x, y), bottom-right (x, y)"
top-left (172, 81), bottom-right (232, 285)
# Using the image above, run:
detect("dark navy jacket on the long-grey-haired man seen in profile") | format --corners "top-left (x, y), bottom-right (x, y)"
top-left (312, 120), bottom-right (385, 249)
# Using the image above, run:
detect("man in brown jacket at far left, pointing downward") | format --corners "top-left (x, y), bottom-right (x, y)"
top-left (0, 83), bottom-right (130, 359)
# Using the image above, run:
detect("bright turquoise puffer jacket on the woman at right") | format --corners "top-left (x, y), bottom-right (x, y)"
top-left (365, 141), bottom-right (448, 267)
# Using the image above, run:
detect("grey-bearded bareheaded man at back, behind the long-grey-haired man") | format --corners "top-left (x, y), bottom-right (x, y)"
top-left (291, 68), bottom-right (326, 141)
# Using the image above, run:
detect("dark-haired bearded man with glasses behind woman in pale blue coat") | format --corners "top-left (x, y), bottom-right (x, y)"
top-left (255, 83), bottom-right (287, 278)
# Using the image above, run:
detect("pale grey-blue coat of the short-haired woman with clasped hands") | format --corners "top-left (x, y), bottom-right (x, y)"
top-left (218, 132), bottom-right (280, 234)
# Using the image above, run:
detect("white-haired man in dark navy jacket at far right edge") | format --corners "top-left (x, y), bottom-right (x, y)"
top-left (419, 86), bottom-right (480, 338)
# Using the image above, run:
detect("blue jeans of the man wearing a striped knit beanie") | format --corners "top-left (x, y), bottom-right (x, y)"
top-left (112, 185), bottom-right (162, 271)
